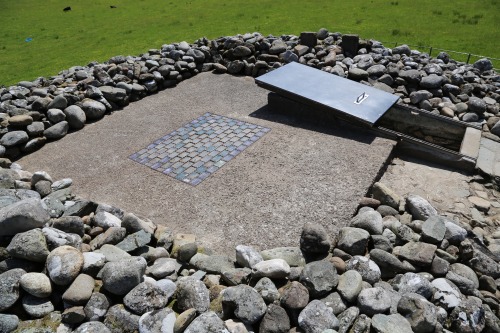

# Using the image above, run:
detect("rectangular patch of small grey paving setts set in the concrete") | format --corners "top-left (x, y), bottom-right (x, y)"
top-left (130, 112), bottom-right (270, 186)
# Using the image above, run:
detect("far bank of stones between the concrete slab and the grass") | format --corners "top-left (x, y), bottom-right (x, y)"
top-left (0, 29), bottom-right (500, 159)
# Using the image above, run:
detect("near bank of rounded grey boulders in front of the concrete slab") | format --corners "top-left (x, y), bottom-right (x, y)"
top-left (0, 159), bottom-right (500, 333)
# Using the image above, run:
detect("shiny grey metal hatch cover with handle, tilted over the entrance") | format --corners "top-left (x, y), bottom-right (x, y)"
top-left (255, 62), bottom-right (399, 125)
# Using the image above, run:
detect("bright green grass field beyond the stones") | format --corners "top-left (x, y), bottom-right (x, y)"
top-left (0, 0), bottom-right (500, 85)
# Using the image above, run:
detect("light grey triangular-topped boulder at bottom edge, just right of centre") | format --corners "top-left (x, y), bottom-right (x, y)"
top-left (298, 300), bottom-right (340, 332)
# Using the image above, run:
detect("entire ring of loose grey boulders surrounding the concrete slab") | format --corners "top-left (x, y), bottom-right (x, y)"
top-left (0, 29), bottom-right (500, 333)
